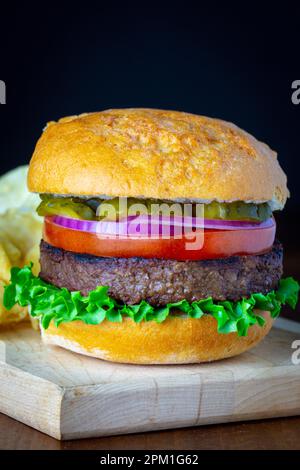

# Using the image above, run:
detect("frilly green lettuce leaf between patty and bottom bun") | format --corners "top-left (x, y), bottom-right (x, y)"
top-left (3, 264), bottom-right (299, 336)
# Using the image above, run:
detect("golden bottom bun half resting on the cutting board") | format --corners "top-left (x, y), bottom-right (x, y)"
top-left (42, 312), bottom-right (273, 364)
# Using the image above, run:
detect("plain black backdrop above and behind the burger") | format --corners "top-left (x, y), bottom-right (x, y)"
top-left (0, 1), bottom-right (300, 211)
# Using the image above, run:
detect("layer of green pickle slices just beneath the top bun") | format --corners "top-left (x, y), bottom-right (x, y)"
top-left (37, 194), bottom-right (272, 222)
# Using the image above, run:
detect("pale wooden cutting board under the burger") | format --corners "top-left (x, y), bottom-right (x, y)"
top-left (0, 324), bottom-right (300, 439)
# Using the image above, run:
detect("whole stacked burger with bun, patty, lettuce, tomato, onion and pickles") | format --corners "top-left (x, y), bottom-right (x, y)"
top-left (4, 109), bottom-right (299, 364)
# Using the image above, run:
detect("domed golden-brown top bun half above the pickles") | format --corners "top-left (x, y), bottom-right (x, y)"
top-left (28, 109), bottom-right (288, 208)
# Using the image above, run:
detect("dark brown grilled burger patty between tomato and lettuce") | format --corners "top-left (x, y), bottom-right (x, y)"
top-left (40, 241), bottom-right (282, 306)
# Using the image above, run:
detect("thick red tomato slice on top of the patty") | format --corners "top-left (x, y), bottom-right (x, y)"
top-left (43, 217), bottom-right (276, 260)
